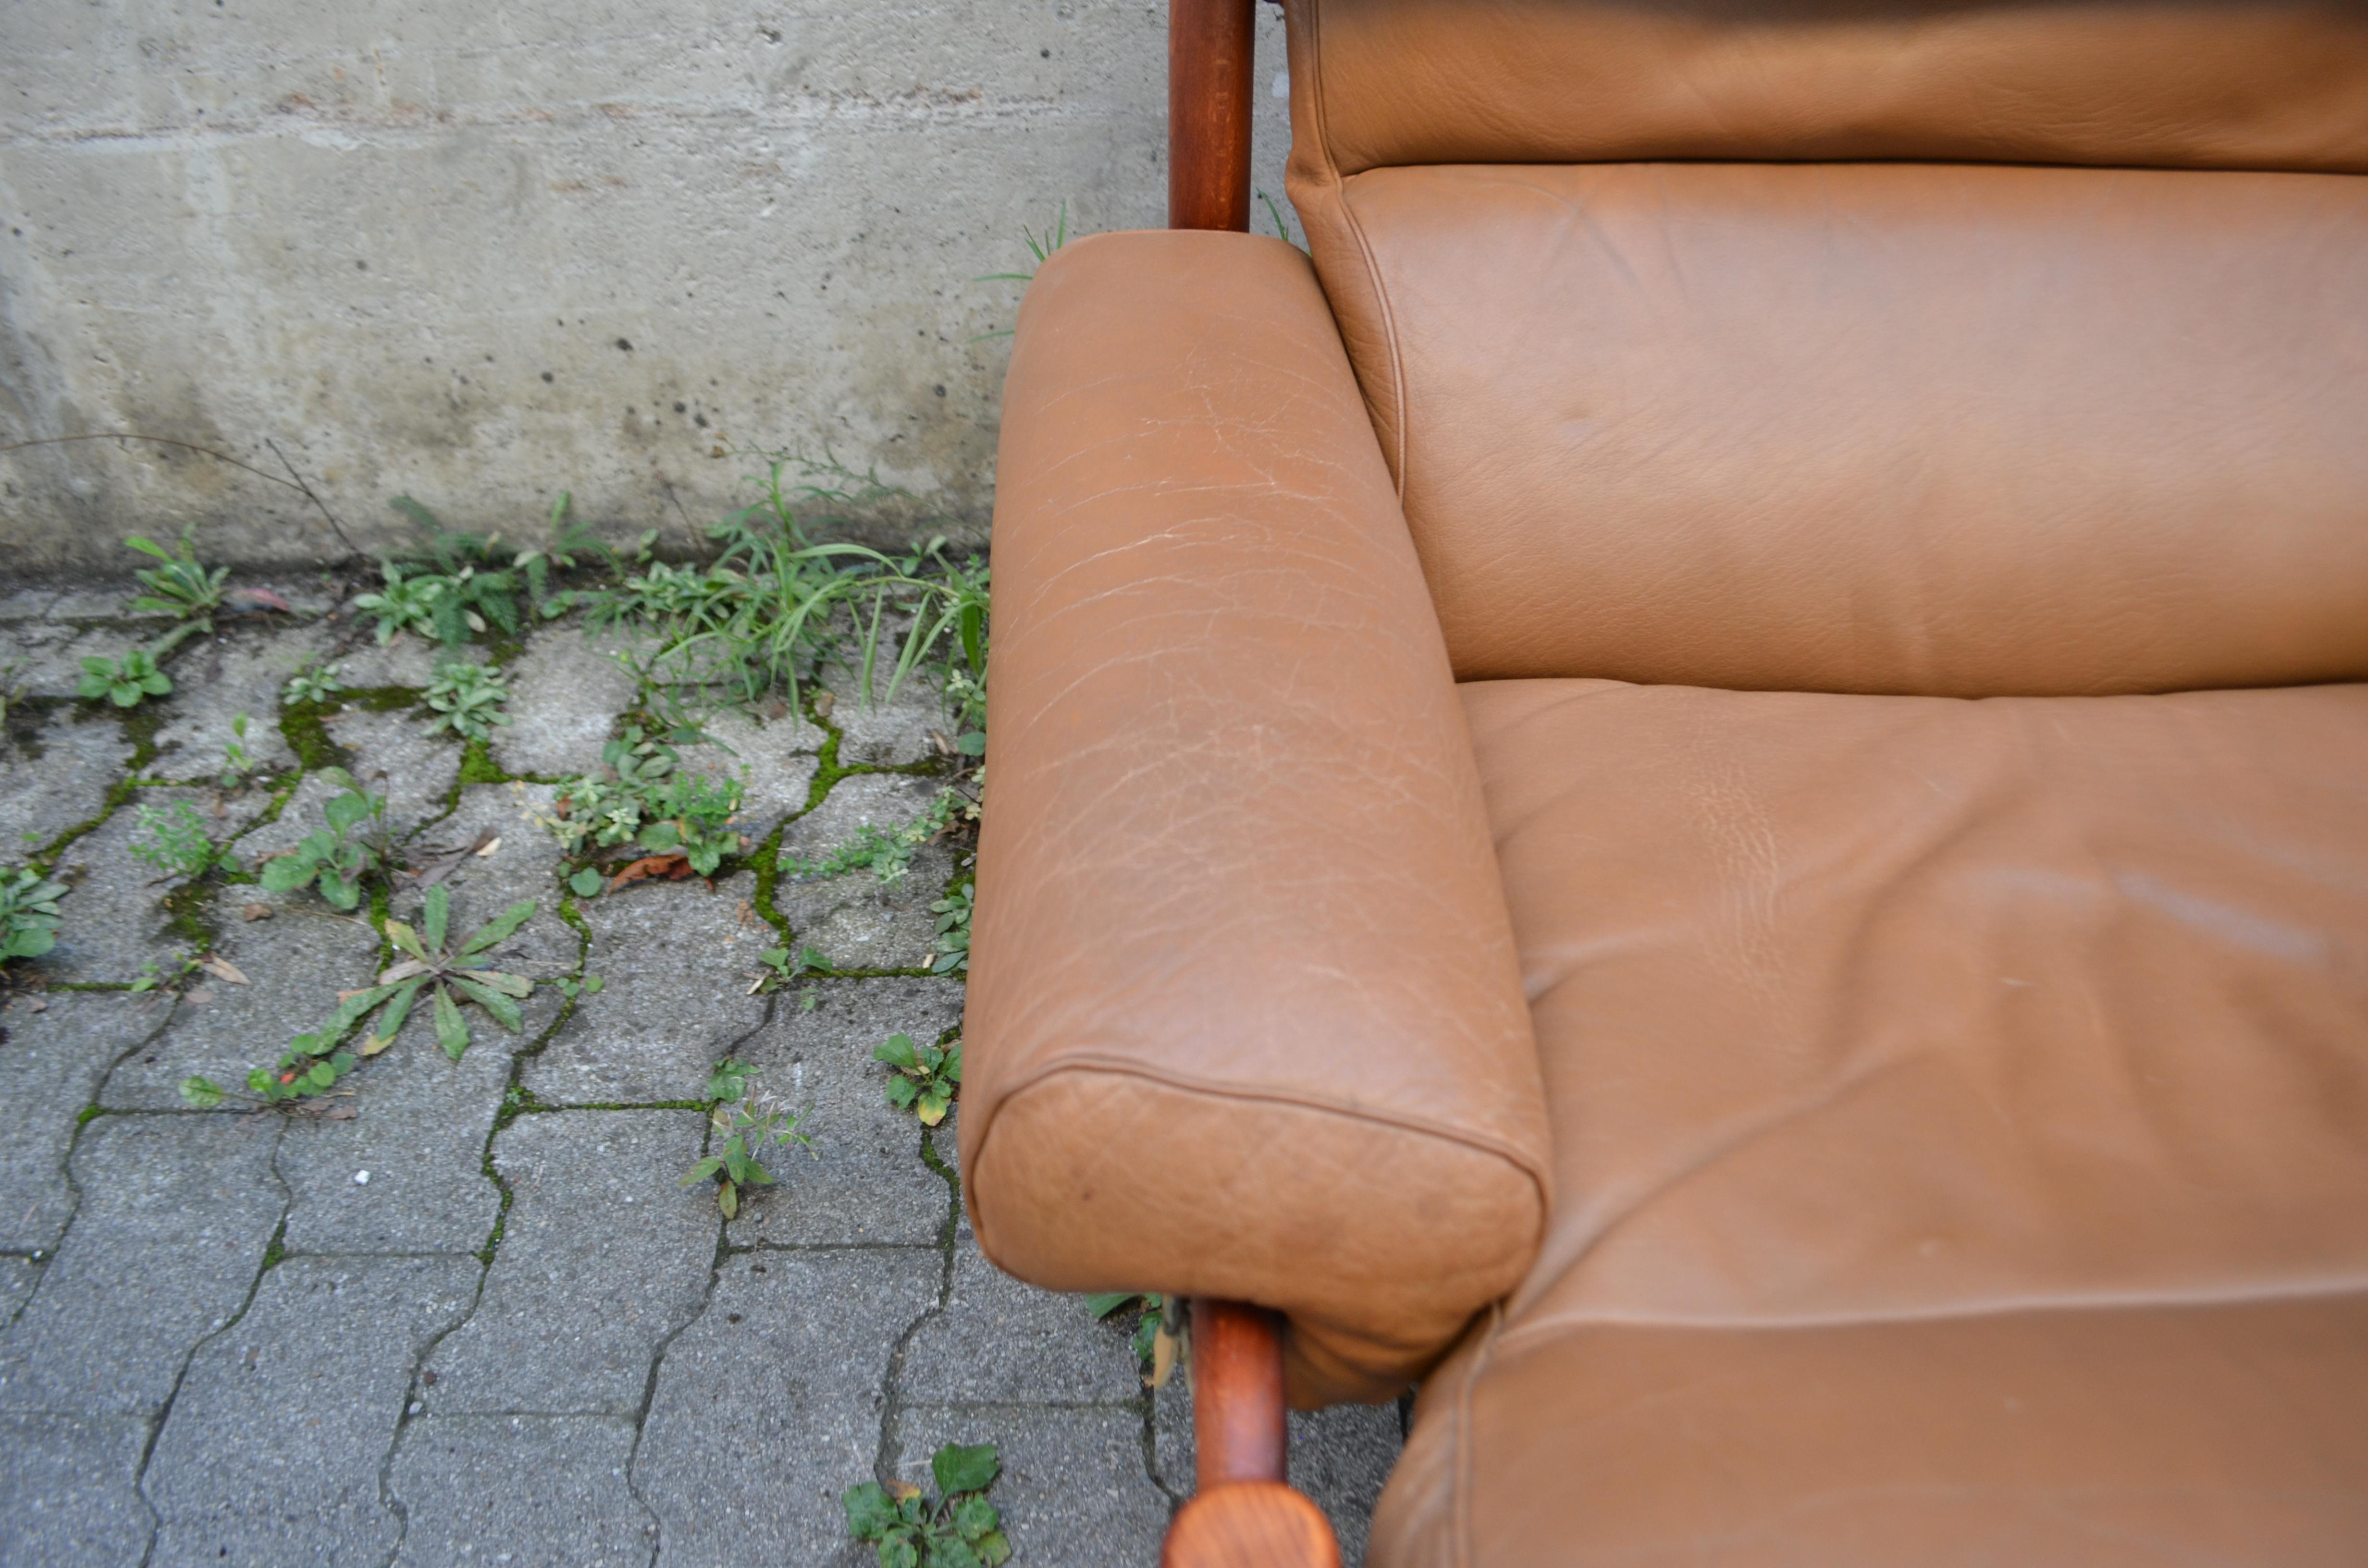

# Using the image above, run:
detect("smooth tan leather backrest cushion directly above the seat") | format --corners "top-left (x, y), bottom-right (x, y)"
top-left (1293, 163), bottom-right (2368, 697)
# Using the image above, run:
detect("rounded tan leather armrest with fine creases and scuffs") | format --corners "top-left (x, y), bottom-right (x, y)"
top-left (962, 232), bottom-right (1549, 1405)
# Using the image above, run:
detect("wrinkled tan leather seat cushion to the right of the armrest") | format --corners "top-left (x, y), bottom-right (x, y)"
top-left (1378, 680), bottom-right (2368, 1563)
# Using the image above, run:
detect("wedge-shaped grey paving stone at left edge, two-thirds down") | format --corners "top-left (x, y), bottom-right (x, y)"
top-left (0, 990), bottom-right (166, 1253)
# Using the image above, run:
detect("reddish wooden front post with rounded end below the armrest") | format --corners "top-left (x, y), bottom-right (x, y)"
top-left (1160, 1298), bottom-right (1340, 1568)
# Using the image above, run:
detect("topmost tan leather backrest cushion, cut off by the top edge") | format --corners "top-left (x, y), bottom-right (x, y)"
top-left (1288, 0), bottom-right (2368, 175)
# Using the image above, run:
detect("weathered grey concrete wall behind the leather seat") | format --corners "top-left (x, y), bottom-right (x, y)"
top-left (0, 0), bottom-right (1288, 576)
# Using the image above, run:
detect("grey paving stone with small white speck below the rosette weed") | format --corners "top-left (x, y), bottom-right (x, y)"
top-left (280, 1028), bottom-right (511, 1267)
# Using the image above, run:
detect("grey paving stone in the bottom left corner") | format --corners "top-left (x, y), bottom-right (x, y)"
top-left (0, 1414), bottom-right (156, 1568)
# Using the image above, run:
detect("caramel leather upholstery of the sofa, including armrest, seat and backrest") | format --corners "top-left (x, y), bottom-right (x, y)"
top-left (962, 0), bottom-right (2368, 1568)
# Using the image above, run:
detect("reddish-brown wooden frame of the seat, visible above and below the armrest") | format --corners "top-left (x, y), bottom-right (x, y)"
top-left (1160, 12), bottom-right (1340, 1568)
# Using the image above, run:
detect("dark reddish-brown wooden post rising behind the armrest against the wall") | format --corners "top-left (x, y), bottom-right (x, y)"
top-left (1168, 0), bottom-right (1258, 232)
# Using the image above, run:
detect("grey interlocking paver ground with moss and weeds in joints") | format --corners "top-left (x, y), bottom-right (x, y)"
top-left (0, 583), bottom-right (1399, 1568)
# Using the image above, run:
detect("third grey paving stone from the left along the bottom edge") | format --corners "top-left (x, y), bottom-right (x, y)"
top-left (388, 1416), bottom-right (658, 1568)
